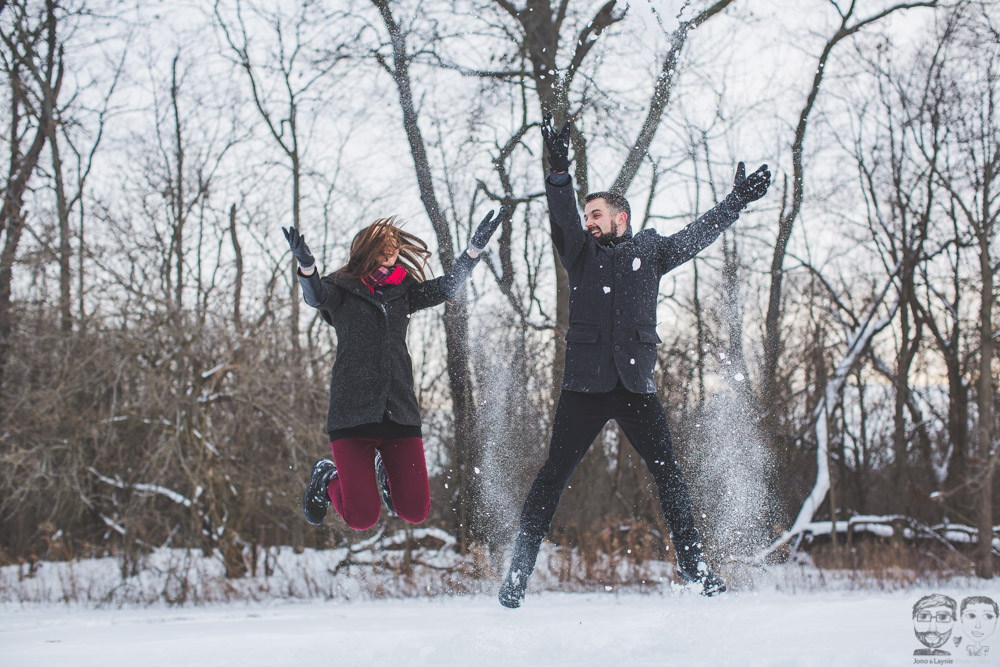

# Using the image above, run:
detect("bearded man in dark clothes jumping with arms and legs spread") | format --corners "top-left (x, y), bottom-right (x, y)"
top-left (499, 114), bottom-right (771, 609)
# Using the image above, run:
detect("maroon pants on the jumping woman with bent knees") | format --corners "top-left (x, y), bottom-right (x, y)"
top-left (326, 438), bottom-right (431, 530)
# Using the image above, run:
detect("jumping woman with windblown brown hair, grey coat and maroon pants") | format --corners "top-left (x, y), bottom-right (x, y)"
top-left (282, 207), bottom-right (505, 530)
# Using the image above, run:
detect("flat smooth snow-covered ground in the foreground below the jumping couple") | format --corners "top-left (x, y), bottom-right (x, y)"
top-left (7, 584), bottom-right (1000, 667)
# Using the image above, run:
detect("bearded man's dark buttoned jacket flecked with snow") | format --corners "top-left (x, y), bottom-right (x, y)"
top-left (545, 174), bottom-right (739, 394)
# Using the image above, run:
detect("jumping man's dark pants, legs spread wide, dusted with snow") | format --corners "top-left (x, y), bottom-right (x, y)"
top-left (511, 382), bottom-right (701, 579)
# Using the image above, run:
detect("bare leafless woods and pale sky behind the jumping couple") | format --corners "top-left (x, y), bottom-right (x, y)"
top-left (0, 0), bottom-right (1000, 596)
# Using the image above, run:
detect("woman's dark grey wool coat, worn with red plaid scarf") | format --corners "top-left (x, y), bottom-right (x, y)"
top-left (299, 252), bottom-right (479, 433)
